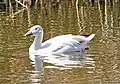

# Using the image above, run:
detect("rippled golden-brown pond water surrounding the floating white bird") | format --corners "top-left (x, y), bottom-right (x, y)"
top-left (0, 2), bottom-right (120, 84)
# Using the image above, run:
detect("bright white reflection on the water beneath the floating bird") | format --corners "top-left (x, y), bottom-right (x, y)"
top-left (29, 50), bottom-right (94, 71)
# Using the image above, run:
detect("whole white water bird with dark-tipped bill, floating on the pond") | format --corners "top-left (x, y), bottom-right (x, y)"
top-left (25, 25), bottom-right (95, 54)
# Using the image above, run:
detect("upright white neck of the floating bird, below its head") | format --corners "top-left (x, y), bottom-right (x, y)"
top-left (29, 32), bottom-right (43, 52)
